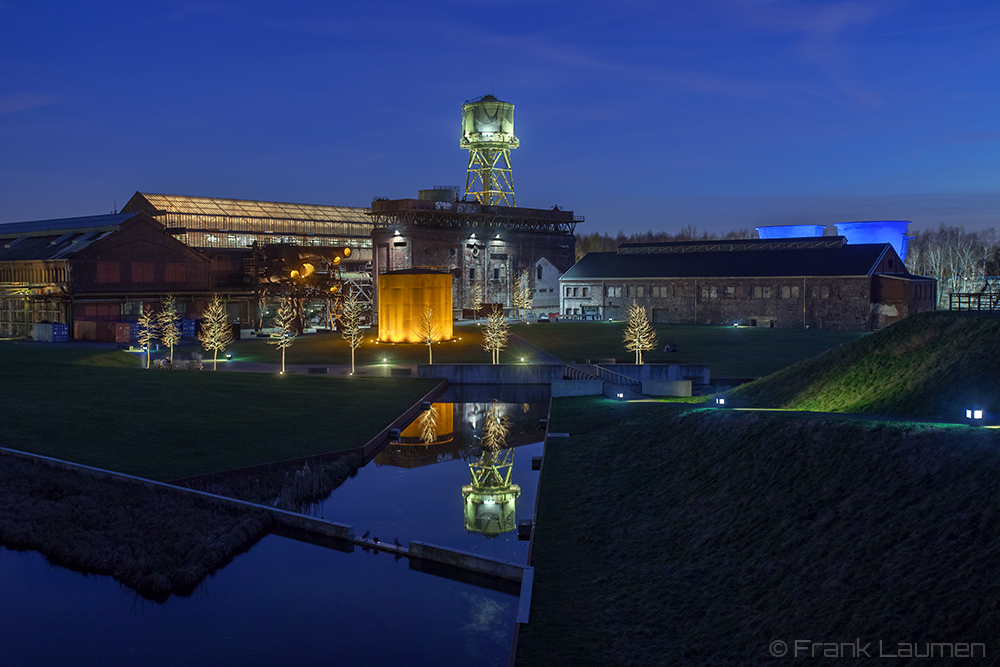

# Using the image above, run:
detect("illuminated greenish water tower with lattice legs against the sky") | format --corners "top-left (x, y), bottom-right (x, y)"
top-left (460, 95), bottom-right (519, 206)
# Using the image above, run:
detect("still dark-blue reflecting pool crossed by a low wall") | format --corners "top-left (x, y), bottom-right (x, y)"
top-left (0, 387), bottom-right (548, 667)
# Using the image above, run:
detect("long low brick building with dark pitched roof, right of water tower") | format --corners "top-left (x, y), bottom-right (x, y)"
top-left (559, 236), bottom-right (936, 331)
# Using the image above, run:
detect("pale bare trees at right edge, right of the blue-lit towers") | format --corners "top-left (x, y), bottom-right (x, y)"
top-left (906, 224), bottom-right (1000, 308)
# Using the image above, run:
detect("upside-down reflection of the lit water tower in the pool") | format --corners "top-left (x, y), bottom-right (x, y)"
top-left (462, 403), bottom-right (521, 537)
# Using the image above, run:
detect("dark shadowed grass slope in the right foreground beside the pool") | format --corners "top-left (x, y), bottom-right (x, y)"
top-left (516, 397), bottom-right (1000, 667)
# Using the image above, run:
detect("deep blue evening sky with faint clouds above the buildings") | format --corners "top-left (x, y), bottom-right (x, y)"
top-left (0, 0), bottom-right (1000, 233)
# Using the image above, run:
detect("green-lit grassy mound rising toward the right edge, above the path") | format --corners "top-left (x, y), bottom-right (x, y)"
top-left (729, 312), bottom-right (1000, 422)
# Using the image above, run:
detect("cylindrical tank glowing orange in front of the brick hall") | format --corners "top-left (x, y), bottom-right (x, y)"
top-left (378, 269), bottom-right (452, 343)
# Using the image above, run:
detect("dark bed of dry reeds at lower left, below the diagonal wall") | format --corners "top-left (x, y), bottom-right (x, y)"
top-left (0, 455), bottom-right (273, 600)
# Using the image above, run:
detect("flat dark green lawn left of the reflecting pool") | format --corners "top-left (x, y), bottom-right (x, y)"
top-left (0, 343), bottom-right (436, 479)
